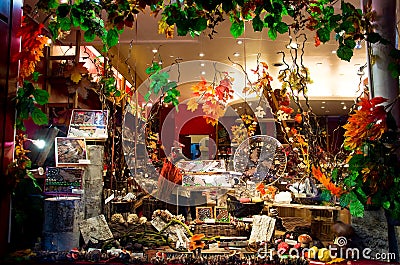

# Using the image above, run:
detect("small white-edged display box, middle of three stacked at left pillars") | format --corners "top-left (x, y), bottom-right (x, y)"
top-left (55, 137), bottom-right (90, 167)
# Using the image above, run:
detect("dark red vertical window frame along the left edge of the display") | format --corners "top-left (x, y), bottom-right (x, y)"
top-left (0, 0), bottom-right (22, 256)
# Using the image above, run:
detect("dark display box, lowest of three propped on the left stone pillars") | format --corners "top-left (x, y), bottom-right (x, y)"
top-left (44, 167), bottom-right (83, 195)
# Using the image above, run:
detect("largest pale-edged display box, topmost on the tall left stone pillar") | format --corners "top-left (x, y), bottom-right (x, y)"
top-left (68, 109), bottom-right (108, 141)
